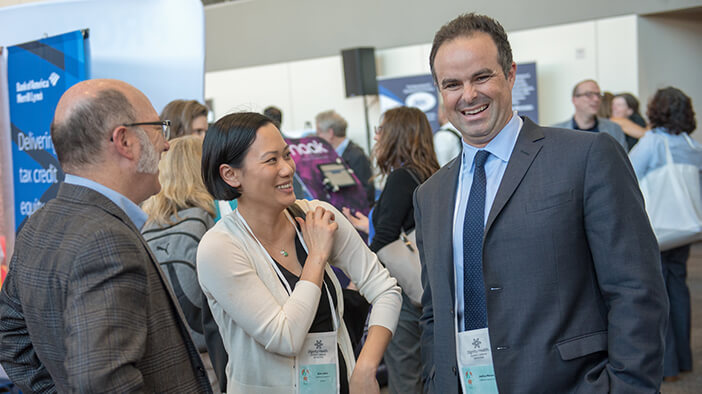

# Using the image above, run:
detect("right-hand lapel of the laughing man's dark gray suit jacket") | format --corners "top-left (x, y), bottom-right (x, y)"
top-left (485, 117), bottom-right (544, 234)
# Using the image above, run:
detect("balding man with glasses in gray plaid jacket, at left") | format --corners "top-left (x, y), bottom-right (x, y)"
top-left (0, 79), bottom-right (211, 392)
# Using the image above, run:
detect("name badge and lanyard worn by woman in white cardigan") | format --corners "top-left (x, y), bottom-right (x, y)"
top-left (236, 209), bottom-right (340, 394)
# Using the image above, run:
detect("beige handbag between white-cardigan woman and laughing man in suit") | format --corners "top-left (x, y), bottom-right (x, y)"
top-left (377, 230), bottom-right (424, 306)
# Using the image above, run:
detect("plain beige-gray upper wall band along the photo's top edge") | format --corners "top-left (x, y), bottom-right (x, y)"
top-left (205, 0), bottom-right (702, 71)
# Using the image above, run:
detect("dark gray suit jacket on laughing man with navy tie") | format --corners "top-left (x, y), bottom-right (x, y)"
top-left (415, 119), bottom-right (668, 394)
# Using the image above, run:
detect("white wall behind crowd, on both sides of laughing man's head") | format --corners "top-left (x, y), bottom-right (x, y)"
top-left (205, 16), bottom-right (638, 148)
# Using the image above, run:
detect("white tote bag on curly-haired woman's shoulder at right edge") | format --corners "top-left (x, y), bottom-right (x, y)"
top-left (639, 134), bottom-right (702, 251)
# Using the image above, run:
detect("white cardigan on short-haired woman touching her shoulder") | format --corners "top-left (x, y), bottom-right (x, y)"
top-left (197, 200), bottom-right (402, 394)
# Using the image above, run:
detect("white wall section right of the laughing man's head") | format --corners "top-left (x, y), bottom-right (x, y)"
top-left (509, 15), bottom-right (638, 125)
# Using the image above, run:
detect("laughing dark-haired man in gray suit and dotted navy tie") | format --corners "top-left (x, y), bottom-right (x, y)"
top-left (415, 14), bottom-right (668, 394)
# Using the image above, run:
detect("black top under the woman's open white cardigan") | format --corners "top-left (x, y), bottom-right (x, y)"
top-left (273, 235), bottom-right (349, 394)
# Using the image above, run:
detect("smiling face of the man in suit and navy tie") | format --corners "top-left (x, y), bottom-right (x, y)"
top-left (434, 32), bottom-right (517, 147)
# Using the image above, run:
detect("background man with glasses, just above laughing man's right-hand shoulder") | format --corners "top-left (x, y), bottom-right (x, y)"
top-left (553, 79), bottom-right (628, 149)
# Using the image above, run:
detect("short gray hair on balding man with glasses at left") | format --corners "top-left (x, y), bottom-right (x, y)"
top-left (51, 89), bottom-right (136, 170)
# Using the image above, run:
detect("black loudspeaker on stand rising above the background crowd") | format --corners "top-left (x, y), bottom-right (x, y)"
top-left (341, 47), bottom-right (378, 152)
